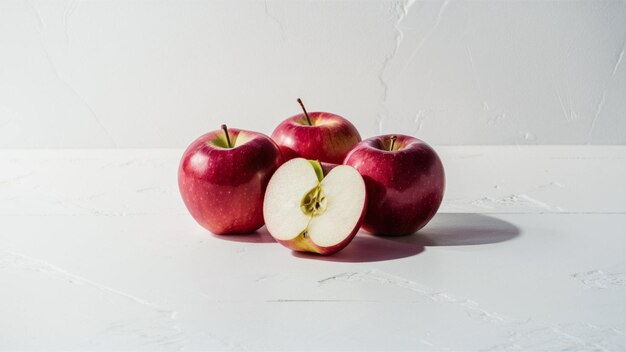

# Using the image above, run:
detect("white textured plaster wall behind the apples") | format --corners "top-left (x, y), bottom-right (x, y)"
top-left (0, 1), bottom-right (626, 148)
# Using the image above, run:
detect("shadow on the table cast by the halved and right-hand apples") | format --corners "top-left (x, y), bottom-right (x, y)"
top-left (293, 214), bottom-right (520, 263)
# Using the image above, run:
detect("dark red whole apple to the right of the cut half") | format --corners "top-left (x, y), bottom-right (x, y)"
top-left (344, 135), bottom-right (445, 236)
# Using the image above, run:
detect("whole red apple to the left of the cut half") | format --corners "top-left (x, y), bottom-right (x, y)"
top-left (178, 128), bottom-right (282, 235)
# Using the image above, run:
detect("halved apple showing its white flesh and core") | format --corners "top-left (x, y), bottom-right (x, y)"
top-left (263, 158), bottom-right (367, 255)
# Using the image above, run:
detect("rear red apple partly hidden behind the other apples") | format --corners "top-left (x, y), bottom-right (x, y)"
top-left (272, 112), bottom-right (361, 164)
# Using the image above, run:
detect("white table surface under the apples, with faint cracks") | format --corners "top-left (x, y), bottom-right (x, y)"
top-left (0, 146), bottom-right (626, 351)
